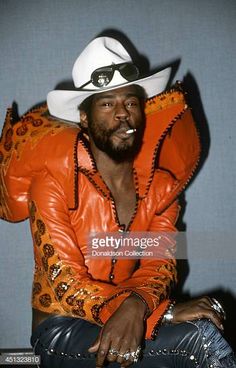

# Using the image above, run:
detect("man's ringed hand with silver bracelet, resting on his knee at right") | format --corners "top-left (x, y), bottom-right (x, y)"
top-left (172, 296), bottom-right (224, 330)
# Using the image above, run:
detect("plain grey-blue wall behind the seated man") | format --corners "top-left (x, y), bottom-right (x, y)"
top-left (0, 0), bottom-right (236, 348)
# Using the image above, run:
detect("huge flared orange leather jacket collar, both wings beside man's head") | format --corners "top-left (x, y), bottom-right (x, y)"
top-left (0, 85), bottom-right (200, 221)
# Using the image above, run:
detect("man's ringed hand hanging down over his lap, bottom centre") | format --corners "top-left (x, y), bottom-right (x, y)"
top-left (89, 295), bottom-right (146, 368)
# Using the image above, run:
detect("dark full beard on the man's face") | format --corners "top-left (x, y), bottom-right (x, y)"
top-left (89, 121), bottom-right (145, 163)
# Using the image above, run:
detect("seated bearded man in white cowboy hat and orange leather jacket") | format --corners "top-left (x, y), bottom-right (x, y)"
top-left (0, 37), bottom-right (234, 368)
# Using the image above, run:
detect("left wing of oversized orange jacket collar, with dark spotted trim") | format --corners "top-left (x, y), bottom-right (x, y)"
top-left (0, 105), bottom-right (79, 222)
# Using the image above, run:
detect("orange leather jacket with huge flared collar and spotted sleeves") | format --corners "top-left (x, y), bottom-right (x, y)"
top-left (0, 85), bottom-right (200, 338)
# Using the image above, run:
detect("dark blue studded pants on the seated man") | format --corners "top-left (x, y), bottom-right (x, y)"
top-left (31, 316), bottom-right (236, 368)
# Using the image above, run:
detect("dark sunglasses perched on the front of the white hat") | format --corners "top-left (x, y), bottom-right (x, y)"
top-left (80, 63), bottom-right (139, 89)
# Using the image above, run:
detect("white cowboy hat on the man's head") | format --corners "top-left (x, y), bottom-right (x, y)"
top-left (47, 37), bottom-right (171, 122)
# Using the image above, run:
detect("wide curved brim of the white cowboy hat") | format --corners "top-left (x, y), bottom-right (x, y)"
top-left (47, 67), bottom-right (171, 123)
